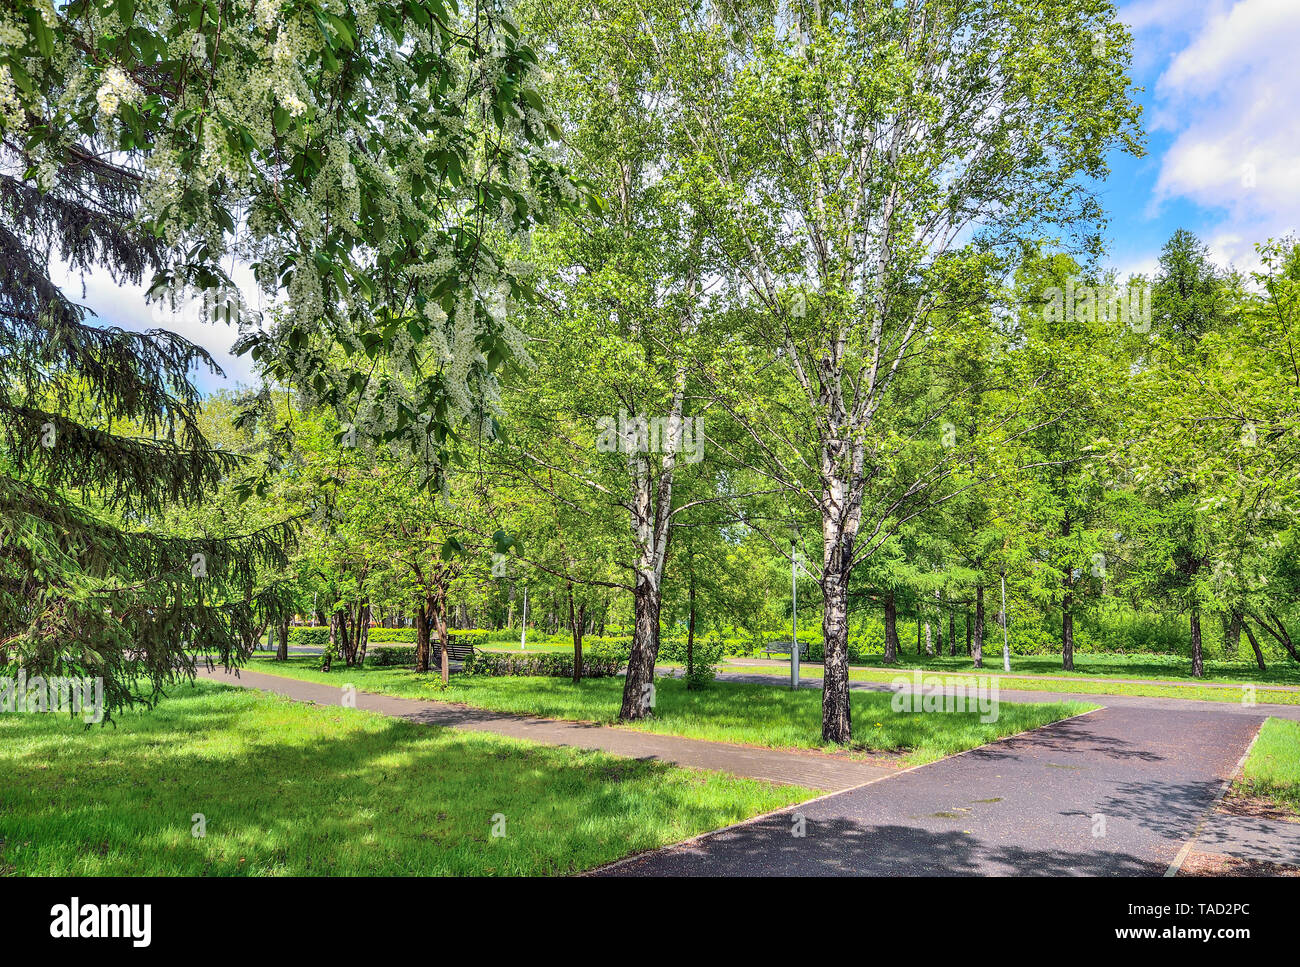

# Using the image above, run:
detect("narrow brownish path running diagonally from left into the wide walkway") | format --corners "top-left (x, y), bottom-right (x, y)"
top-left (199, 668), bottom-right (897, 792)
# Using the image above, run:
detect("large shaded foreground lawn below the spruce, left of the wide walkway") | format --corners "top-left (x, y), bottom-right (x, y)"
top-left (0, 682), bottom-right (814, 876)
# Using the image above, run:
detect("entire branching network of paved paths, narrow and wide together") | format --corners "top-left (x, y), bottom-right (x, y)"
top-left (195, 671), bottom-right (1300, 876)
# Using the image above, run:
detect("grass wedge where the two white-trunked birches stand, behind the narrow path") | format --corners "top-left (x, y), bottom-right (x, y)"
top-left (239, 656), bottom-right (1096, 764)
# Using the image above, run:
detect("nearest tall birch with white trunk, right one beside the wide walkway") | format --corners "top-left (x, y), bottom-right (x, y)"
top-left (647, 0), bottom-right (1139, 742)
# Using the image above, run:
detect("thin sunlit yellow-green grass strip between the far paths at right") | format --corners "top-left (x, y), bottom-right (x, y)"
top-left (720, 658), bottom-right (1300, 704)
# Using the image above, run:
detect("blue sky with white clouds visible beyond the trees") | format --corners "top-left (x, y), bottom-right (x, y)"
top-left (55, 0), bottom-right (1300, 391)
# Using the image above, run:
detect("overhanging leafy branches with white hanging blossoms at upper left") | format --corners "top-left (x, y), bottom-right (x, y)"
top-left (0, 0), bottom-right (576, 483)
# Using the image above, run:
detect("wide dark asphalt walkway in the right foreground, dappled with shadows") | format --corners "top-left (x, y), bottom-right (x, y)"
top-left (598, 693), bottom-right (1264, 876)
